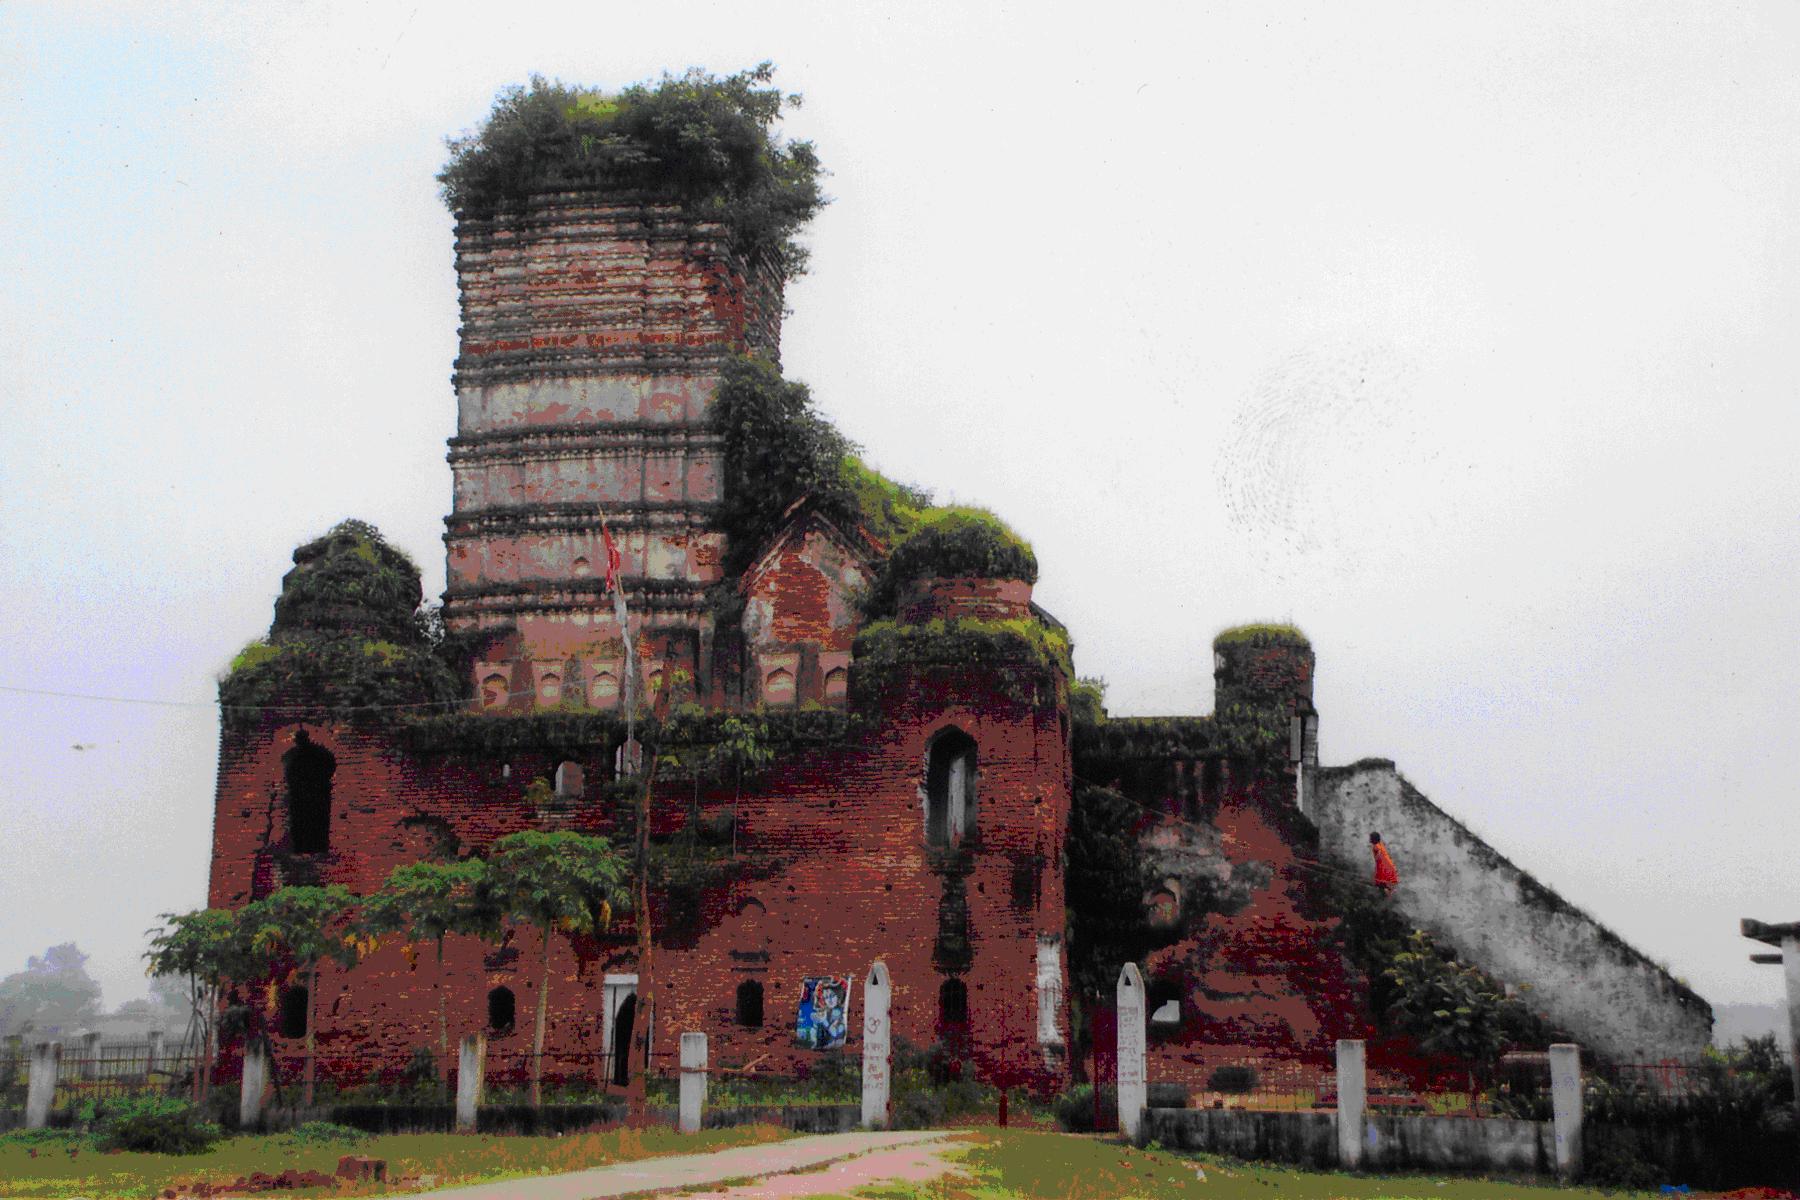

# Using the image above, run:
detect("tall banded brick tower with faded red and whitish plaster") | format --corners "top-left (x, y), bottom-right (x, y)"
top-left (445, 189), bottom-right (783, 709)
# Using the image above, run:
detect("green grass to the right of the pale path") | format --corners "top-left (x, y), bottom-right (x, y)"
top-left (828, 1128), bottom-right (1648, 1200)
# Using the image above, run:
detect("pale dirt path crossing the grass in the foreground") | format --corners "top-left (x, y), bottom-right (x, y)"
top-left (427, 1130), bottom-right (972, 1200)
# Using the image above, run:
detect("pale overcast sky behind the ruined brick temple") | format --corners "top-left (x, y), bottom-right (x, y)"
top-left (0, 0), bottom-right (1800, 1004)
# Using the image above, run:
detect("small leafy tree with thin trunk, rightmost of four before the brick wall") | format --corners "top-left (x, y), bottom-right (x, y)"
top-left (488, 829), bottom-right (630, 1105)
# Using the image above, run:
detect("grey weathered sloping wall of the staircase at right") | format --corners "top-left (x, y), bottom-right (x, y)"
top-left (1307, 759), bottom-right (1712, 1063)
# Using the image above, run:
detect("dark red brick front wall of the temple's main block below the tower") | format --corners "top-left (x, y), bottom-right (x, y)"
top-left (209, 662), bottom-right (1069, 1081)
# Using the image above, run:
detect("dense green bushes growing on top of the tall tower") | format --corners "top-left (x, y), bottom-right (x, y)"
top-left (437, 63), bottom-right (824, 273)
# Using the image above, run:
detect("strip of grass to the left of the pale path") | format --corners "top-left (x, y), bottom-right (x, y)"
top-left (0, 1124), bottom-right (794, 1200)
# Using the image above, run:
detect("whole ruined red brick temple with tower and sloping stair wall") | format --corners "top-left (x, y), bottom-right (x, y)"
top-left (209, 77), bottom-right (1712, 1090)
